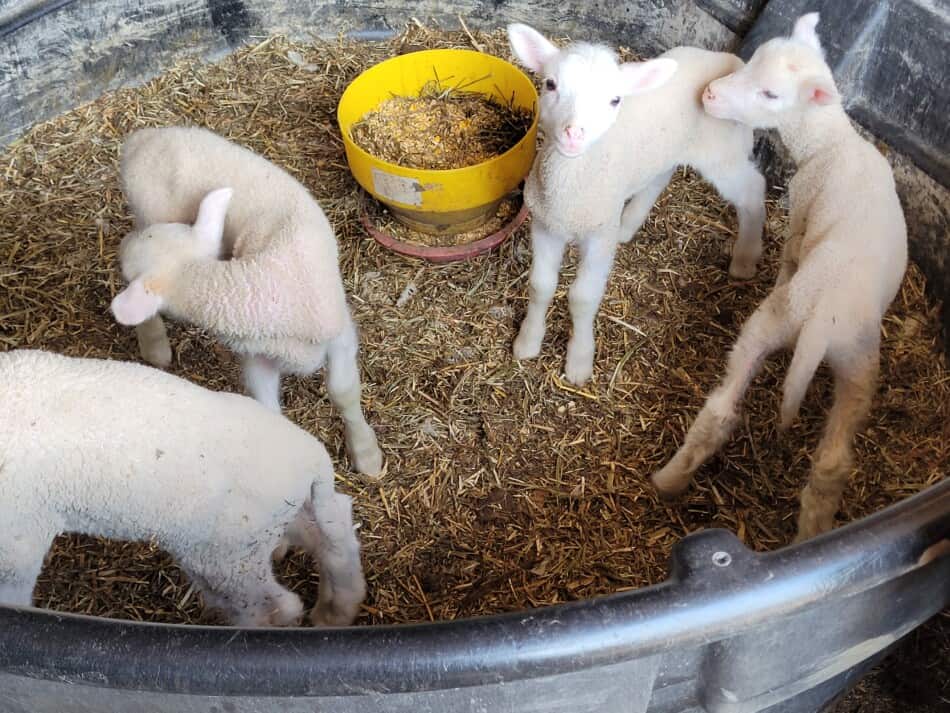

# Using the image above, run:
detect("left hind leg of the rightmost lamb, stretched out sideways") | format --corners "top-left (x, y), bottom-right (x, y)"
top-left (651, 290), bottom-right (796, 496)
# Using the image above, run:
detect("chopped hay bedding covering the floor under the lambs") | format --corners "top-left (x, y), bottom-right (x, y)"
top-left (0, 27), bottom-right (950, 624)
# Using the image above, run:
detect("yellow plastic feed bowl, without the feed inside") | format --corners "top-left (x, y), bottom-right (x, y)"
top-left (337, 50), bottom-right (538, 234)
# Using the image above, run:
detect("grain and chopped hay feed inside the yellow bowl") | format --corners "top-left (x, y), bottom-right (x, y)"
top-left (350, 68), bottom-right (534, 170)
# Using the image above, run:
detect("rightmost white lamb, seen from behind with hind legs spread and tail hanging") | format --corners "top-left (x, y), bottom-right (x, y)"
top-left (653, 13), bottom-right (907, 540)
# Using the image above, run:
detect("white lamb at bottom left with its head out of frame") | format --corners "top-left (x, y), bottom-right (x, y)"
top-left (0, 350), bottom-right (366, 626)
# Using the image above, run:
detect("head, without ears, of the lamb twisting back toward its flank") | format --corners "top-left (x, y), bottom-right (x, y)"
top-left (119, 223), bottom-right (216, 282)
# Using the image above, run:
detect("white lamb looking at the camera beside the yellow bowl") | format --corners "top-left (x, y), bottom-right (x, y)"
top-left (508, 24), bottom-right (765, 384)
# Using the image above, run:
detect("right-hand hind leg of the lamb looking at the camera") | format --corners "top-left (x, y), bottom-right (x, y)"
top-left (702, 161), bottom-right (765, 280)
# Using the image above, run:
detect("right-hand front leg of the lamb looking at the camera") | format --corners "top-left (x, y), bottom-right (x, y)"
top-left (564, 235), bottom-right (617, 385)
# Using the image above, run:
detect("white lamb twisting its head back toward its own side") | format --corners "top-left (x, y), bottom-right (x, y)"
top-left (112, 127), bottom-right (383, 475)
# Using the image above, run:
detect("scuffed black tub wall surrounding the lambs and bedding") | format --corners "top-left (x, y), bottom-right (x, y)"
top-left (0, 0), bottom-right (950, 713)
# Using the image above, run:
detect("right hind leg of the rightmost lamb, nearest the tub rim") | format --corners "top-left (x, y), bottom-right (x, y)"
top-left (795, 342), bottom-right (879, 542)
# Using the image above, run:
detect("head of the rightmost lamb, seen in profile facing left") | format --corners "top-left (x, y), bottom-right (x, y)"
top-left (703, 13), bottom-right (839, 129)
